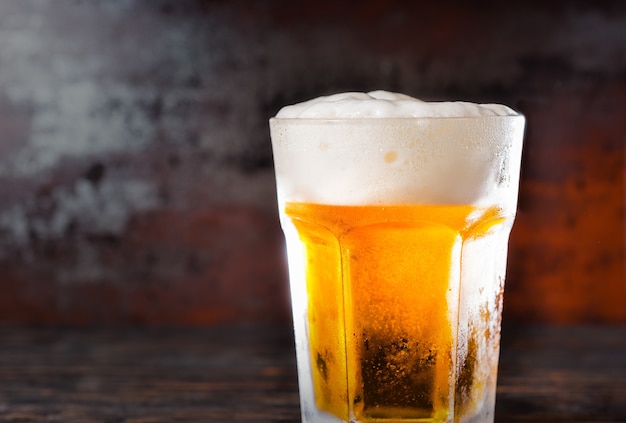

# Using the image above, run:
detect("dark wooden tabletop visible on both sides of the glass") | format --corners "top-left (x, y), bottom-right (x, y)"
top-left (0, 326), bottom-right (626, 423)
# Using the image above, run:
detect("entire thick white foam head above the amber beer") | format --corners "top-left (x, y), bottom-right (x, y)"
top-left (270, 91), bottom-right (524, 208)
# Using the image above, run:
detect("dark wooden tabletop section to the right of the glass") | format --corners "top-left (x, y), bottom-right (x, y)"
top-left (496, 326), bottom-right (626, 422)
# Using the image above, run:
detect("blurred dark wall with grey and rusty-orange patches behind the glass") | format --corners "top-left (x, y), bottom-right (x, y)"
top-left (0, 0), bottom-right (626, 325)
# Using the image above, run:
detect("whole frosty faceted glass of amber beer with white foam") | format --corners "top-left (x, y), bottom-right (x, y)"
top-left (270, 91), bottom-right (525, 423)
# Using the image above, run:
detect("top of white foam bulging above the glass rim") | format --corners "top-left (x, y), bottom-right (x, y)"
top-left (276, 90), bottom-right (517, 119)
